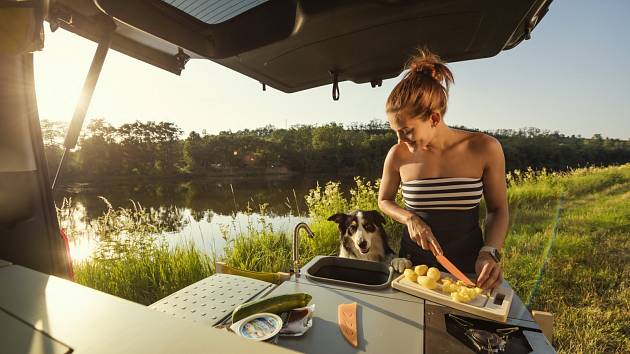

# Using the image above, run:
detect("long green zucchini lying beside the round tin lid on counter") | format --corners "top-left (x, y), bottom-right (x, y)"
top-left (232, 293), bottom-right (313, 323)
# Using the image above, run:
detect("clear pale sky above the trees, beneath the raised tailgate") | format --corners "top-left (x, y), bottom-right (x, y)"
top-left (35, 0), bottom-right (630, 139)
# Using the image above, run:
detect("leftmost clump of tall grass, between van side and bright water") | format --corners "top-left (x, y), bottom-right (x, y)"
top-left (67, 198), bottom-right (214, 305)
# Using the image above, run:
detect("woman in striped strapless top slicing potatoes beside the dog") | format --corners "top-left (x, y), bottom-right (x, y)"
top-left (378, 49), bottom-right (508, 289)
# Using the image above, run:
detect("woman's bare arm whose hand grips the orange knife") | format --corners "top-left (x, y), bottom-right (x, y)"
top-left (378, 145), bottom-right (442, 254)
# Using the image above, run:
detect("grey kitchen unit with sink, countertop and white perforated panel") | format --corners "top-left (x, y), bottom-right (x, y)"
top-left (150, 256), bottom-right (555, 353)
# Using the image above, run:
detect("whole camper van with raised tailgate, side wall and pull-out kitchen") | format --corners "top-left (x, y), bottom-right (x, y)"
top-left (0, 0), bottom-right (555, 353)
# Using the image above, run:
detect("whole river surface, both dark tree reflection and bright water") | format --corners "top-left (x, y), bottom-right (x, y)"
top-left (56, 176), bottom-right (368, 260)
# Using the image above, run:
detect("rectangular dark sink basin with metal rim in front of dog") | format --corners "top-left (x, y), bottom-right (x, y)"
top-left (304, 257), bottom-right (394, 289)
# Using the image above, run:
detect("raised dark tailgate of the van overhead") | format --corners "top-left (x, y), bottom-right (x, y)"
top-left (48, 0), bottom-right (551, 92)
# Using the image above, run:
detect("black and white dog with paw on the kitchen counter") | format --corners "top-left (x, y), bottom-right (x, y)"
top-left (328, 210), bottom-right (411, 273)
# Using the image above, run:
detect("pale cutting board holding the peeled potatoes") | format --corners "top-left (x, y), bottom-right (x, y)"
top-left (392, 273), bottom-right (514, 323)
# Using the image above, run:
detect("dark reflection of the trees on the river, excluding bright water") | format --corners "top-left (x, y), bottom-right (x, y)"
top-left (56, 176), bottom-right (338, 221)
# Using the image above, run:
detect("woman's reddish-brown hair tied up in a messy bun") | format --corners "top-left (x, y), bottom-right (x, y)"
top-left (385, 48), bottom-right (454, 120)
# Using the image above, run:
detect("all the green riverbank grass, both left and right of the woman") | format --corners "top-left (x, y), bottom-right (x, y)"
top-left (60, 164), bottom-right (630, 353)
